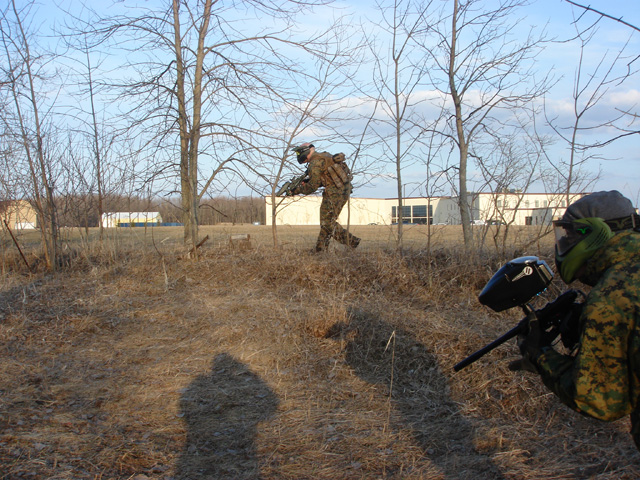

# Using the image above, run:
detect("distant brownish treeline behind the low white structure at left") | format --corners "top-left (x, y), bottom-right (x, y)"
top-left (56, 196), bottom-right (266, 227)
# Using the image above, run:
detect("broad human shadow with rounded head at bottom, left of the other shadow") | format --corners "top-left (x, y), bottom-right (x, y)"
top-left (176, 354), bottom-right (278, 480)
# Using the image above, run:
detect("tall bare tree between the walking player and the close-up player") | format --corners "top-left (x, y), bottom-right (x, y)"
top-left (425, 0), bottom-right (548, 248)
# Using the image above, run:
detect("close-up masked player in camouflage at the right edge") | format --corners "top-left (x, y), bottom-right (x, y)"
top-left (519, 190), bottom-right (640, 450)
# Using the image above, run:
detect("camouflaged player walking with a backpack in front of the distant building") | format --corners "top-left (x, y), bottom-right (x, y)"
top-left (291, 143), bottom-right (360, 252)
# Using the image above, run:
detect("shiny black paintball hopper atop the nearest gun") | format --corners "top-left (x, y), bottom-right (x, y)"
top-left (478, 256), bottom-right (553, 312)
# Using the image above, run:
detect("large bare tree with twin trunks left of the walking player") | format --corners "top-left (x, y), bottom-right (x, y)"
top-left (72, 0), bottom-right (344, 255)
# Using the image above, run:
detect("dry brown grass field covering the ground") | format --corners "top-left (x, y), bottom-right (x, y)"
top-left (0, 225), bottom-right (640, 480)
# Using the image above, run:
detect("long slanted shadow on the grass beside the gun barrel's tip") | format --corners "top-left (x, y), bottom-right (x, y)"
top-left (330, 311), bottom-right (504, 480)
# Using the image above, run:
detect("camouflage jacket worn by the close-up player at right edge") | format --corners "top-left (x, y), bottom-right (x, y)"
top-left (537, 231), bottom-right (640, 422)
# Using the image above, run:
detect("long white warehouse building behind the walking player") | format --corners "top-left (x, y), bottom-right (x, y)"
top-left (265, 191), bottom-right (586, 225)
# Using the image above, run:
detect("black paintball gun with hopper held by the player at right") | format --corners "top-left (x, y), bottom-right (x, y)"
top-left (453, 256), bottom-right (582, 372)
